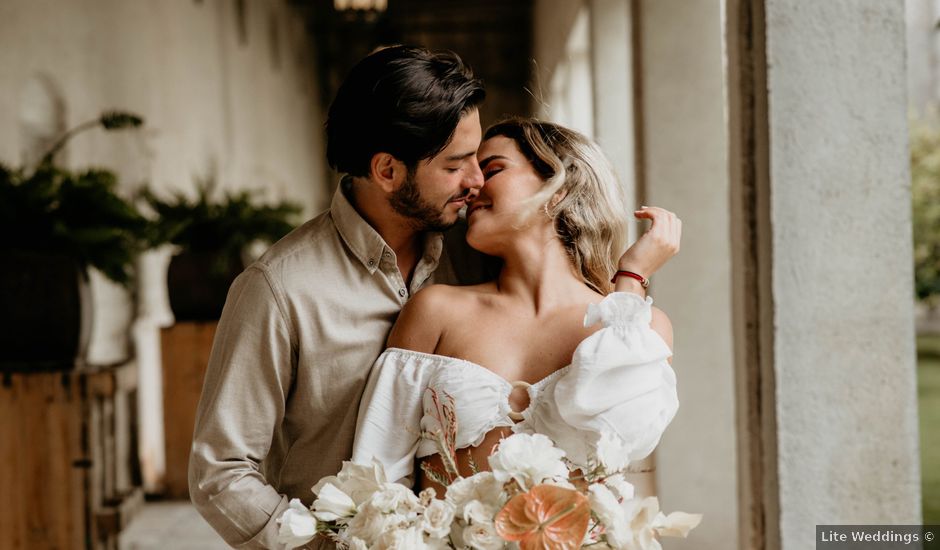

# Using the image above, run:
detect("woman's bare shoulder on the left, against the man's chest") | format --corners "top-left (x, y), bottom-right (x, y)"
top-left (386, 283), bottom-right (495, 353)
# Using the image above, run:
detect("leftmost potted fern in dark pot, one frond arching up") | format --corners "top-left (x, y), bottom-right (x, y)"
top-left (0, 112), bottom-right (147, 371)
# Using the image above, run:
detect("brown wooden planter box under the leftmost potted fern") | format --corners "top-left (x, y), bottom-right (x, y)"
top-left (0, 363), bottom-right (143, 550)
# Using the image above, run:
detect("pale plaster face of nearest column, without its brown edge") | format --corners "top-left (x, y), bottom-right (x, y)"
top-left (766, 0), bottom-right (921, 550)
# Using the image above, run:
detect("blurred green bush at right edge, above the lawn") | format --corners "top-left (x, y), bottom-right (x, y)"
top-left (911, 111), bottom-right (940, 306)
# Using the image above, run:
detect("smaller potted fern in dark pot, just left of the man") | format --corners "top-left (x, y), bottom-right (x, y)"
top-left (142, 179), bottom-right (301, 321)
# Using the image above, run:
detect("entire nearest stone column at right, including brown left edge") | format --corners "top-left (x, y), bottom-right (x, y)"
top-left (728, 0), bottom-right (920, 550)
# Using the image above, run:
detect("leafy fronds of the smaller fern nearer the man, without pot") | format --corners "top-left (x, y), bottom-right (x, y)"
top-left (141, 179), bottom-right (302, 268)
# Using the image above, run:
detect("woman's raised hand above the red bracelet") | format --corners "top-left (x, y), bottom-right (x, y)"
top-left (618, 206), bottom-right (682, 284)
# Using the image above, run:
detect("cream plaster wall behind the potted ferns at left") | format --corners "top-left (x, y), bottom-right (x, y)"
top-left (0, 0), bottom-right (330, 489)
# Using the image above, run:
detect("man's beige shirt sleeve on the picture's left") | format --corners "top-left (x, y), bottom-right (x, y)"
top-left (189, 264), bottom-right (293, 548)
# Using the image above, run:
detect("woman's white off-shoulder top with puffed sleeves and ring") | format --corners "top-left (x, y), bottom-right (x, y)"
top-left (352, 292), bottom-right (679, 485)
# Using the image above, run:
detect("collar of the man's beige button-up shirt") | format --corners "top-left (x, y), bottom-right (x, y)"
top-left (330, 178), bottom-right (444, 273)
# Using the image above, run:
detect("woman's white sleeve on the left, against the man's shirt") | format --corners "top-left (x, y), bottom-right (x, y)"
top-left (352, 351), bottom-right (429, 487)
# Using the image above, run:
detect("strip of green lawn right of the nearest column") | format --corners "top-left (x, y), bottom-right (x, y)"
top-left (917, 334), bottom-right (940, 525)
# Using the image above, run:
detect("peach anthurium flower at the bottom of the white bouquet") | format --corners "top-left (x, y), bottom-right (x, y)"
top-left (495, 485), bottom-right (591, 550)
